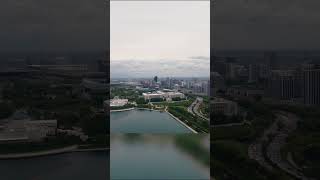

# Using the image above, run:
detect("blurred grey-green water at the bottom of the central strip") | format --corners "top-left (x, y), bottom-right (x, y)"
top-left (110, 134), bottom-right (210, 180)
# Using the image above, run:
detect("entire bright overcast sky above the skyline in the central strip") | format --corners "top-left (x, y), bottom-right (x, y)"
top-left (110, 1), bottom-right (210, 77)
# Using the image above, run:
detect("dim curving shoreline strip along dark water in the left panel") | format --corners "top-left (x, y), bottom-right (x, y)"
top-left (0, 145), bottom-right (110, 160)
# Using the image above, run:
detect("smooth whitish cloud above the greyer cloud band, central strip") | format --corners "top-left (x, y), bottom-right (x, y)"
top-left (110, 1), bottom-right (210, 60)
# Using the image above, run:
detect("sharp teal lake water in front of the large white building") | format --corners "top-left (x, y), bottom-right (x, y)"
top-left (110, 110), bottom-right (191, 133)
